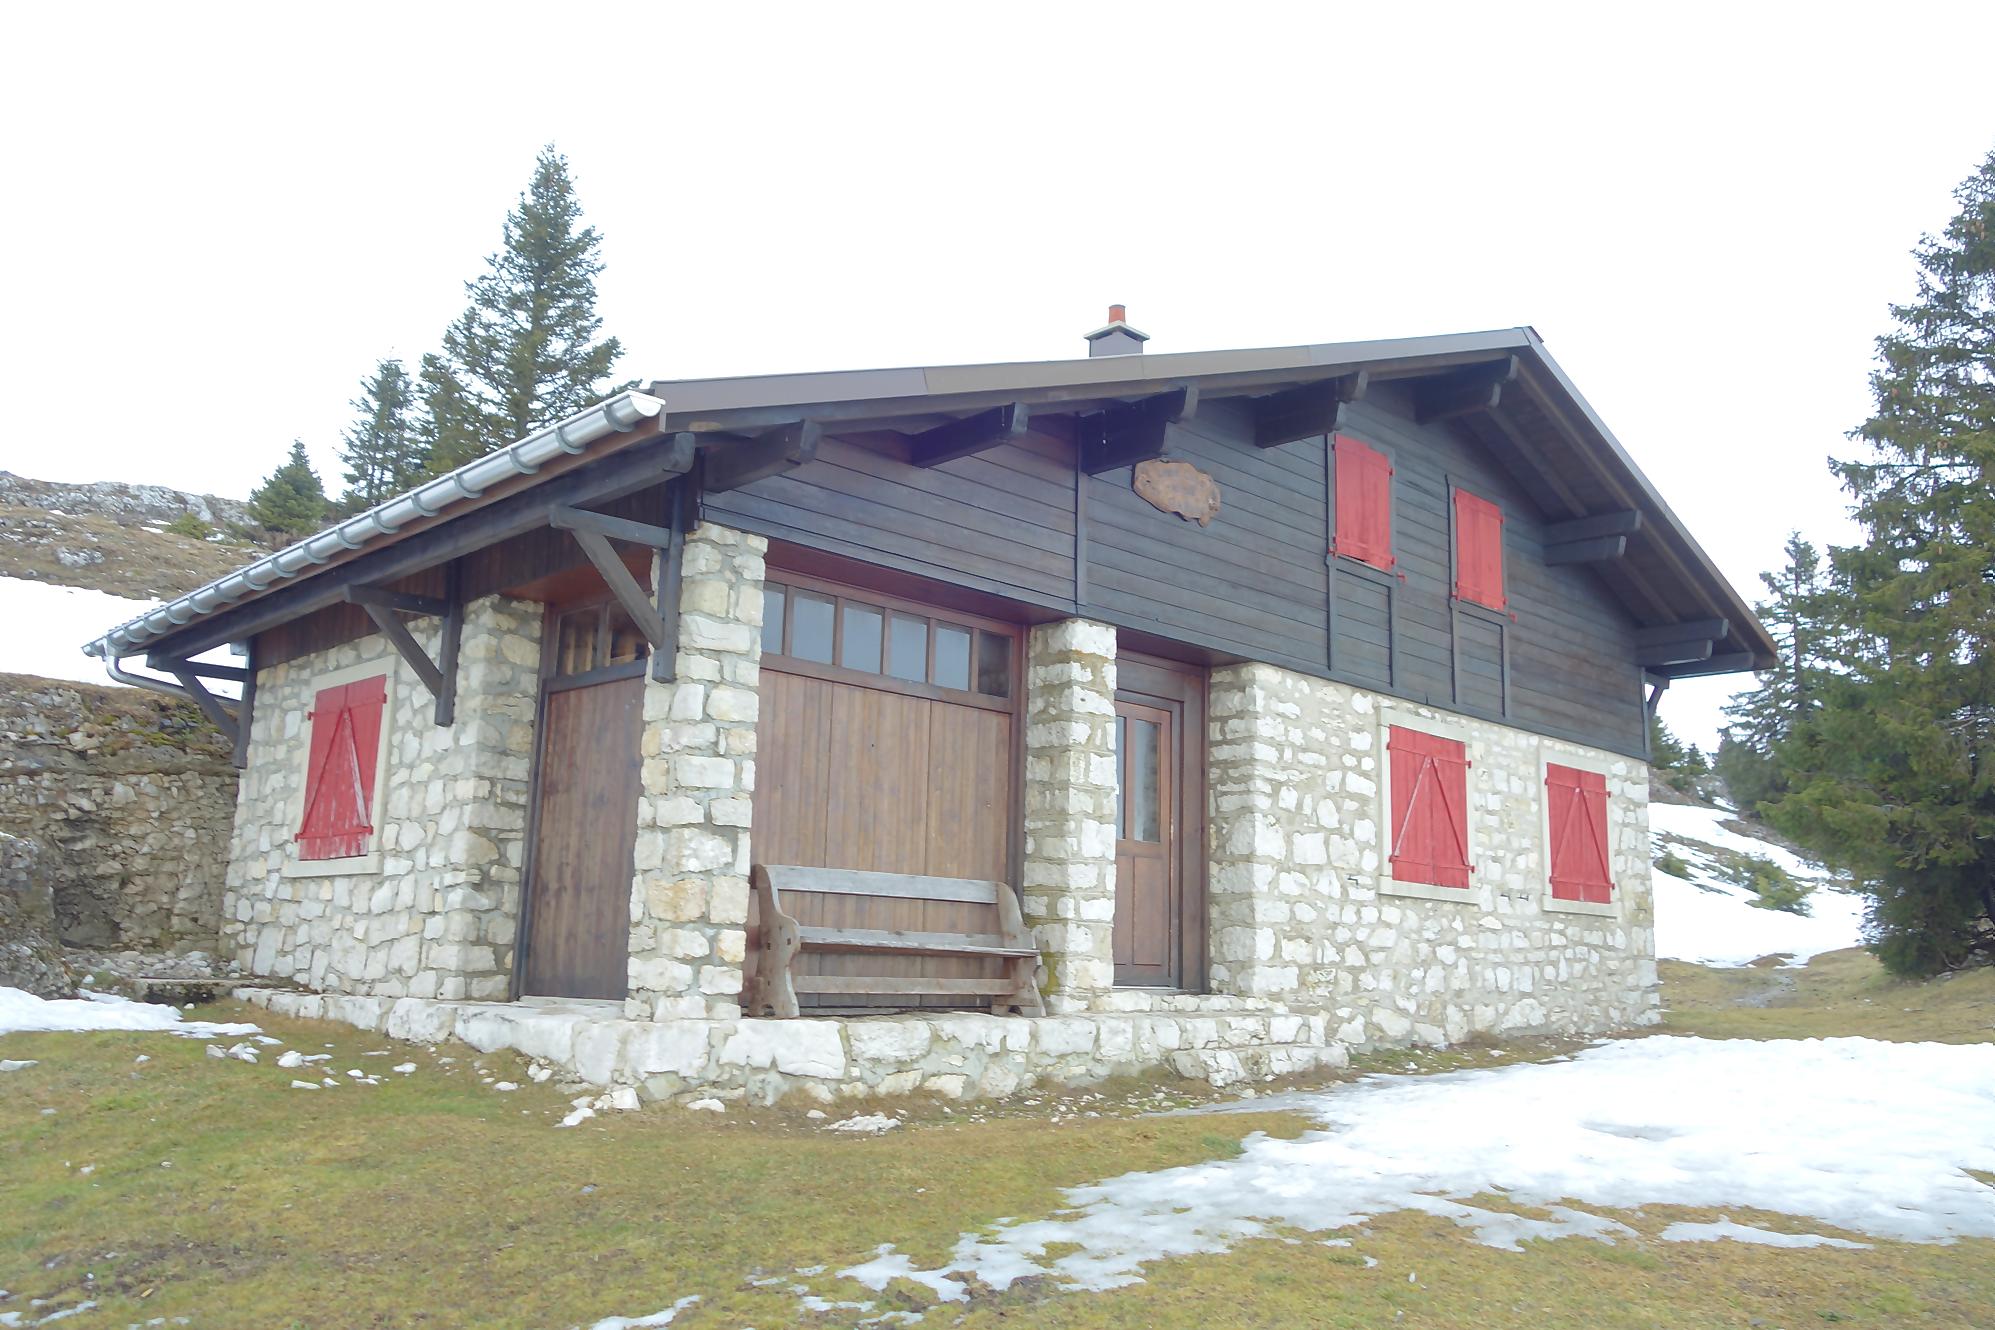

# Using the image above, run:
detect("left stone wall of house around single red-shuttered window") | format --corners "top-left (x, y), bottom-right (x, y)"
top-left (221, 596), bottom-right (541, 999)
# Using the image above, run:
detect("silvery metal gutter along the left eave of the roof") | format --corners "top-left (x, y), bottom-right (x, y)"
top-left (84, 391), bottom-right (664, 696)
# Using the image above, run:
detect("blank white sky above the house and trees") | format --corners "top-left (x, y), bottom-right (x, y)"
top-left (0, 0), bottom-right (1995, 742)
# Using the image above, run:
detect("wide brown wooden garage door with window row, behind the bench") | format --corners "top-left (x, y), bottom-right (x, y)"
top-left (750, 574), bottom-right (1019, 1005)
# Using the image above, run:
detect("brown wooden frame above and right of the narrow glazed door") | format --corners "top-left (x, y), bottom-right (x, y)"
top-left (1113, 650), bottom-right (1211, 993)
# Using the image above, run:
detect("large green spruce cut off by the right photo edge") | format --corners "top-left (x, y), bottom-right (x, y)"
top-left (1770, 154), bottom-right (1995, 975)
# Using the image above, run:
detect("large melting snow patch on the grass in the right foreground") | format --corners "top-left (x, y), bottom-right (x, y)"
top-left (597, 1037), bottom-right (1995, 1330)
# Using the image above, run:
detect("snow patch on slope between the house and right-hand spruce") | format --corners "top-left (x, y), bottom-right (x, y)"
top-left (1648, 804), bottom-right (1863, 965)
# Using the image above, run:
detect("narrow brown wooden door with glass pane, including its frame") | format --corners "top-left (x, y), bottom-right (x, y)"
top-left (1113, 654), bottom-right (1205, 991)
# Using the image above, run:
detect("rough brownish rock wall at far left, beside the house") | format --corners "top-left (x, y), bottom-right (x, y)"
top-left (0, 674), bottom-right (235, 951)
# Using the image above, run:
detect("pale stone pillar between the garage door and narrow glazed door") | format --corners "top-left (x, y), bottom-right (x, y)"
top-left (1023, 618), bottom-right (1115, 1011)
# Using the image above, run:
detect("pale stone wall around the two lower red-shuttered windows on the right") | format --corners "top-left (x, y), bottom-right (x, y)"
top-left (1209, 664), bottom-right (1658, 1047)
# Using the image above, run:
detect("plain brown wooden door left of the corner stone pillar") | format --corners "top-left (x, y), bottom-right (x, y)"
top-left (521, 674), bottom-right (644, 997)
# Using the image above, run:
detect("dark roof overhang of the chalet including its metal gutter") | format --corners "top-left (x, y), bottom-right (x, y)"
top-left (84, 327), bottom-right (1776, 678)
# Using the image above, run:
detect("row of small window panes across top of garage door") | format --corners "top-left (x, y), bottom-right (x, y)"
top-left (762, 582), bottom-right (1015, 700)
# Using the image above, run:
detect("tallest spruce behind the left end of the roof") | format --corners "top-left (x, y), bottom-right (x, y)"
top-left (412, 144), bottom-right (622, 473)
